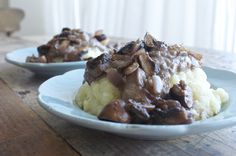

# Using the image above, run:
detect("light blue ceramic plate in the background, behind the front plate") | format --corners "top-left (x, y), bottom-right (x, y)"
top-left (5, 47), bottom-right (86, 76)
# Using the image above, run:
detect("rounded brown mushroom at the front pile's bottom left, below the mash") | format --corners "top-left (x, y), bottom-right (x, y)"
top-left (98, 100), bottom-right (130, 123)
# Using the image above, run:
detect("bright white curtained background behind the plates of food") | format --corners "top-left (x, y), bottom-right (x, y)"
top-left (10, 0), bottom-right (236, 52)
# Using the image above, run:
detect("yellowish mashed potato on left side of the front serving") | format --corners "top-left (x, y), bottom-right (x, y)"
top-left (75, 78), bottom-right (120, 116)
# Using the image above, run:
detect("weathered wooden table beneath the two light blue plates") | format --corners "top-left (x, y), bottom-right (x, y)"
top-left (0, 37), bottom-right (236, 156)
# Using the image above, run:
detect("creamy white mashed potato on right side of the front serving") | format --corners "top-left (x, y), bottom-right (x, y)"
top-left (170, 68), bottom-right (229, 120)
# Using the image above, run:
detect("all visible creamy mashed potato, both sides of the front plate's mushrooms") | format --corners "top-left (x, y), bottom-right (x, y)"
top-left (76, 68), bottom-right (229, 120)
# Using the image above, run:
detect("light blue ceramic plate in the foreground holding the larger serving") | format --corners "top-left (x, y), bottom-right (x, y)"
top-left (38, 67), bottom-right (236, 140)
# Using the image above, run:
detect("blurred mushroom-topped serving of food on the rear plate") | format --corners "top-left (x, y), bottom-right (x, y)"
top-left (26, 28), bottom-right (110, 63)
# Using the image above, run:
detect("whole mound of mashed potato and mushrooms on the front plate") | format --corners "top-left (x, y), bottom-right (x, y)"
top-left (75, 33), bottom-right (229, 124)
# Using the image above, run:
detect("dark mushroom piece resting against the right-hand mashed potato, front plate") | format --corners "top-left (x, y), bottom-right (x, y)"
top-left (169, 80), bottom-right (193, 109)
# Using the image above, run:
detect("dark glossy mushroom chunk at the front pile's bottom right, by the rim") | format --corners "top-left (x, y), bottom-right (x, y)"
top-left (150, 100), bottom-right (193, 125)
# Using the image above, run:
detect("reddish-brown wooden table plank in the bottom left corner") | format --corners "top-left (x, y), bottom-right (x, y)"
top-left (0, 79), bottom-right (79, 156)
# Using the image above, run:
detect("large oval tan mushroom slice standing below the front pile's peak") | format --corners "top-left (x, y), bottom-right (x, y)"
top-left (138, 53), bottom-right (160, 76)
